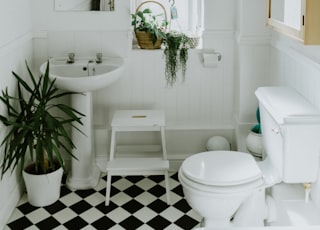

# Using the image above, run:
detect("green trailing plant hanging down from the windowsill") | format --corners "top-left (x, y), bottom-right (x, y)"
top-left (164, 32), bottom-right (189, 86)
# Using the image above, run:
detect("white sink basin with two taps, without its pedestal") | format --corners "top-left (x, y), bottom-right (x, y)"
top-left (40, 58), bottom-right (124, 92)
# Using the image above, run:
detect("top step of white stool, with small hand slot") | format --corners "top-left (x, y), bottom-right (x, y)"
top-left (111, 110), bottom-right (165, 127)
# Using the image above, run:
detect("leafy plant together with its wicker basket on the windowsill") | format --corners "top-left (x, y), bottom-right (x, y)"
top-left (131, 5), bottom-right (168, 49)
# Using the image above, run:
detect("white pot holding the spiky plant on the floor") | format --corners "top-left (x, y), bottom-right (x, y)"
top-left (23, 167), bottom-right (63, 207)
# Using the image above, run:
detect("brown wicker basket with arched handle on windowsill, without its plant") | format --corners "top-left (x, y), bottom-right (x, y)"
top-left (134, 1), bottom-right (167, 49)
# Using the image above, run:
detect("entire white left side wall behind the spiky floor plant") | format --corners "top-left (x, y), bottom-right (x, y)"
top-left (0, 0), bottom-right (33, 229)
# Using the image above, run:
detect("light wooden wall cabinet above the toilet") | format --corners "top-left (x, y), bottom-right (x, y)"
top-left (267, 0), bottom-right (320, 45)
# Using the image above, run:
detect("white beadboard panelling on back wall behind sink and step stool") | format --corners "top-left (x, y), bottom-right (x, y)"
top-left (34, 30), bottom-right (235, 170)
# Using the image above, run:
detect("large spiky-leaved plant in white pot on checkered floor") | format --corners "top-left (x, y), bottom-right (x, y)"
top-left (0, 62), bottom-right (84, 206)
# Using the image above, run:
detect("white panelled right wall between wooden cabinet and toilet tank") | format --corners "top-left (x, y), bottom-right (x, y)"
top-left (270, 34), bottom-right (320, 109)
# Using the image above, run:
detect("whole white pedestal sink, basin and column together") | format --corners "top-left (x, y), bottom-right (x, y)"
top-left (40, 58), bottom-right (124, 189)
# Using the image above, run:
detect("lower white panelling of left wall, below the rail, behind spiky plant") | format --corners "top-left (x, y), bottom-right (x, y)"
top-left (0, 32), bottom-right (33, 229)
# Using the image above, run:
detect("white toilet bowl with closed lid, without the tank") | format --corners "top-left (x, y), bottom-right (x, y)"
top-left (178, 151), bottom-right (264, 227)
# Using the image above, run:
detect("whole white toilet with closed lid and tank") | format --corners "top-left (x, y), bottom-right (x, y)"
top-left (179, 87), bottom-right (320, 229)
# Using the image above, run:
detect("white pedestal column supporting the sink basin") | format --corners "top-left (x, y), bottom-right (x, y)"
top-left (67, 92), bottom-right (100, 189)
